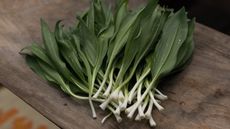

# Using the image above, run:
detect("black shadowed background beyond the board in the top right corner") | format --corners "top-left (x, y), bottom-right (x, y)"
top-left (160, 0), bottom-right (230, 35)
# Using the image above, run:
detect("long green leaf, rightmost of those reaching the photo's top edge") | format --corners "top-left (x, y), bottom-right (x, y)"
top-left (117, 0), bottom-right (158, 82)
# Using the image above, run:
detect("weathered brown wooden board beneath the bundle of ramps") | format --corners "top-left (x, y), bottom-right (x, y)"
top-left (0, 0), bottom-right (230, 129)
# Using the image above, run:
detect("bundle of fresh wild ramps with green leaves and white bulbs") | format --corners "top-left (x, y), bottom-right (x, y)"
top-left (21, 0), bottom-right (194, 126)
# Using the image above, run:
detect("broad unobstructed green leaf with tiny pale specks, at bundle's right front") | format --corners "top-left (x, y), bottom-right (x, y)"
top-left (151, 8), bottom-right (188, 79)
